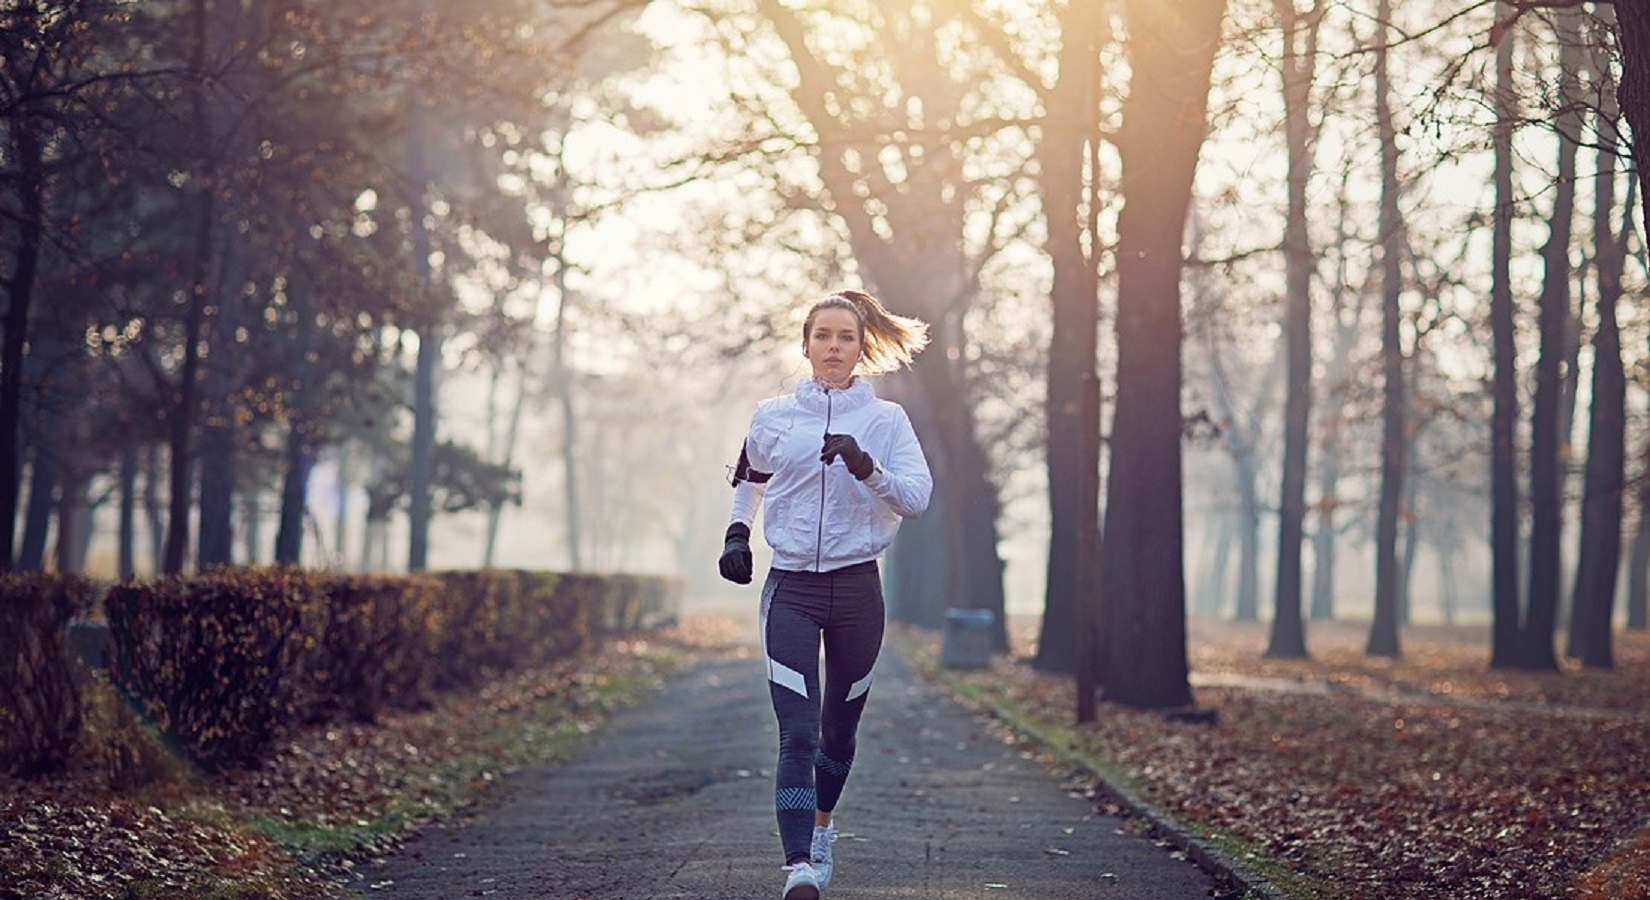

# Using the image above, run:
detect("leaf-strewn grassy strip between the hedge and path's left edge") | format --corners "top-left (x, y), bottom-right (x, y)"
top-left (0, 623), bottom-right (739, 900)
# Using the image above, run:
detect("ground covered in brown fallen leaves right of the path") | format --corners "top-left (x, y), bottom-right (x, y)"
top-left (917, 623), bottom-right (1650, 898)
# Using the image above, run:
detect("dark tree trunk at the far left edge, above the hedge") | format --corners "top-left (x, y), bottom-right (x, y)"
top-left (0, 117), bottom-right (46, 571)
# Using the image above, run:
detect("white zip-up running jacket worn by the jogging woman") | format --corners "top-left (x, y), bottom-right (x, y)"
top-left (733, 378), bottom-right (934, 571)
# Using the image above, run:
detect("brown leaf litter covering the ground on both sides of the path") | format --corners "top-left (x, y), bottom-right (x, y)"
top-left (0, 616), bottom-right (1650, 900)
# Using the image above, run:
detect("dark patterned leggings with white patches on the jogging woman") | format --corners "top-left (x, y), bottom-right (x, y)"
top-left (762, 560), bottom-right (883, 865)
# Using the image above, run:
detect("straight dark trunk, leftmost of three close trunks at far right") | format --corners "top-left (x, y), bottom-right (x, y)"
top-left (1490, 3), bottom-right (1523, 669)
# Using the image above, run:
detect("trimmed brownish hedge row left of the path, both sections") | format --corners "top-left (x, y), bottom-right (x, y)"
top-left (0, 568), bottom-right (681, 773)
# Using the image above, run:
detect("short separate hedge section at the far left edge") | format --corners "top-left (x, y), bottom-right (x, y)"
top-left (0, 573), bottom-right (91, 776)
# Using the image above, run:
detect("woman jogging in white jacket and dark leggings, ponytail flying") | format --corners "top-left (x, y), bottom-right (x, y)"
top-left (721, 291), bottom-right (934, 900)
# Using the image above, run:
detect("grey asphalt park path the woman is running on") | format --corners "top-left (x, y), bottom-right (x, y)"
top-left (360, 634), bottom-right (1221, 900)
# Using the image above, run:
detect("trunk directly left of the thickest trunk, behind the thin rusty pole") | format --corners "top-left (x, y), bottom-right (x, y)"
top-left (1036, 3), bottom-right (1104, 672)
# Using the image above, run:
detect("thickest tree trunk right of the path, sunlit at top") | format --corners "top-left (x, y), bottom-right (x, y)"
top-left (1101, 0), bottom-right (1226, 708)
